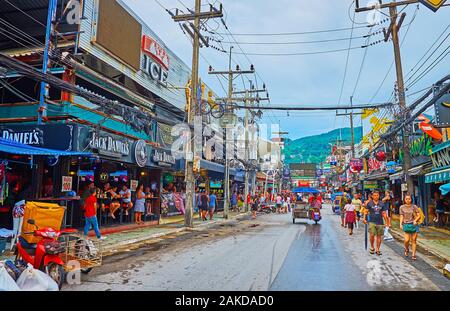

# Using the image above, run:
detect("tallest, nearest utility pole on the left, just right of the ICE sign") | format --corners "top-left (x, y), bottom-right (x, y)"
top-left (172, 0), bottom-right (223, 228)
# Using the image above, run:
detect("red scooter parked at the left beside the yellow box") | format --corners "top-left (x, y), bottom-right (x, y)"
top-left (16, 219), bottom-right (66, 289)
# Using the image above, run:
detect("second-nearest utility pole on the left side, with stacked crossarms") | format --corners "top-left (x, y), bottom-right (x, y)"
top-left (209, 50), bottom-right (263, 219)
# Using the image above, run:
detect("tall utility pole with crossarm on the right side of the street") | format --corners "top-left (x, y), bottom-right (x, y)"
top-left (356, 0), bottom-right (418, 194)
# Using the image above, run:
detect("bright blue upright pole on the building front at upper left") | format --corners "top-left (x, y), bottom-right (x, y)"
top-left (38, 0), bottom-right (58, 124)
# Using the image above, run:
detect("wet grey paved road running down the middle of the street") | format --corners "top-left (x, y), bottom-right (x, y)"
top-left (64, 208), bottom-right (450, 291)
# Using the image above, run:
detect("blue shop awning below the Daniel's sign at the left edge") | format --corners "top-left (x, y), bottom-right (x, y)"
top-left (0, 138), bottom-right (92, 156)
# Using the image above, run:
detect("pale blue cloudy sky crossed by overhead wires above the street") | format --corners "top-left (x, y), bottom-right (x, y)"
top-left (123, 0), bottom-right (450, 139)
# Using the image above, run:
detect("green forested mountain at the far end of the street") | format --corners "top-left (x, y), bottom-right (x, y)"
top-left (284, 127), bottom-right (363, 163)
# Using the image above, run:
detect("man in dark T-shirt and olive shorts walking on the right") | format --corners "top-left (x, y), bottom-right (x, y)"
top-left (363, 191), bottom-right (388, 256)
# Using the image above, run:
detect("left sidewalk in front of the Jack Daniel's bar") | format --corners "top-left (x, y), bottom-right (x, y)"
top-left (0, 212), bottom-right (249, 261)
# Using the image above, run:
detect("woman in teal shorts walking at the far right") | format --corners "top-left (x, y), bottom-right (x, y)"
top-left (400, 194), bottom-right (420, 260)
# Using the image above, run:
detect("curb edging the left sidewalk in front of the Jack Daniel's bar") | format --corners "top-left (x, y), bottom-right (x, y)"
top-left (103, 212), bottom-right (250, 258)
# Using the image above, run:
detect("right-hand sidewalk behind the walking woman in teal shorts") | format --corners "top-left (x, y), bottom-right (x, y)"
top-left (390, 216), bottom-right (450, 265)
